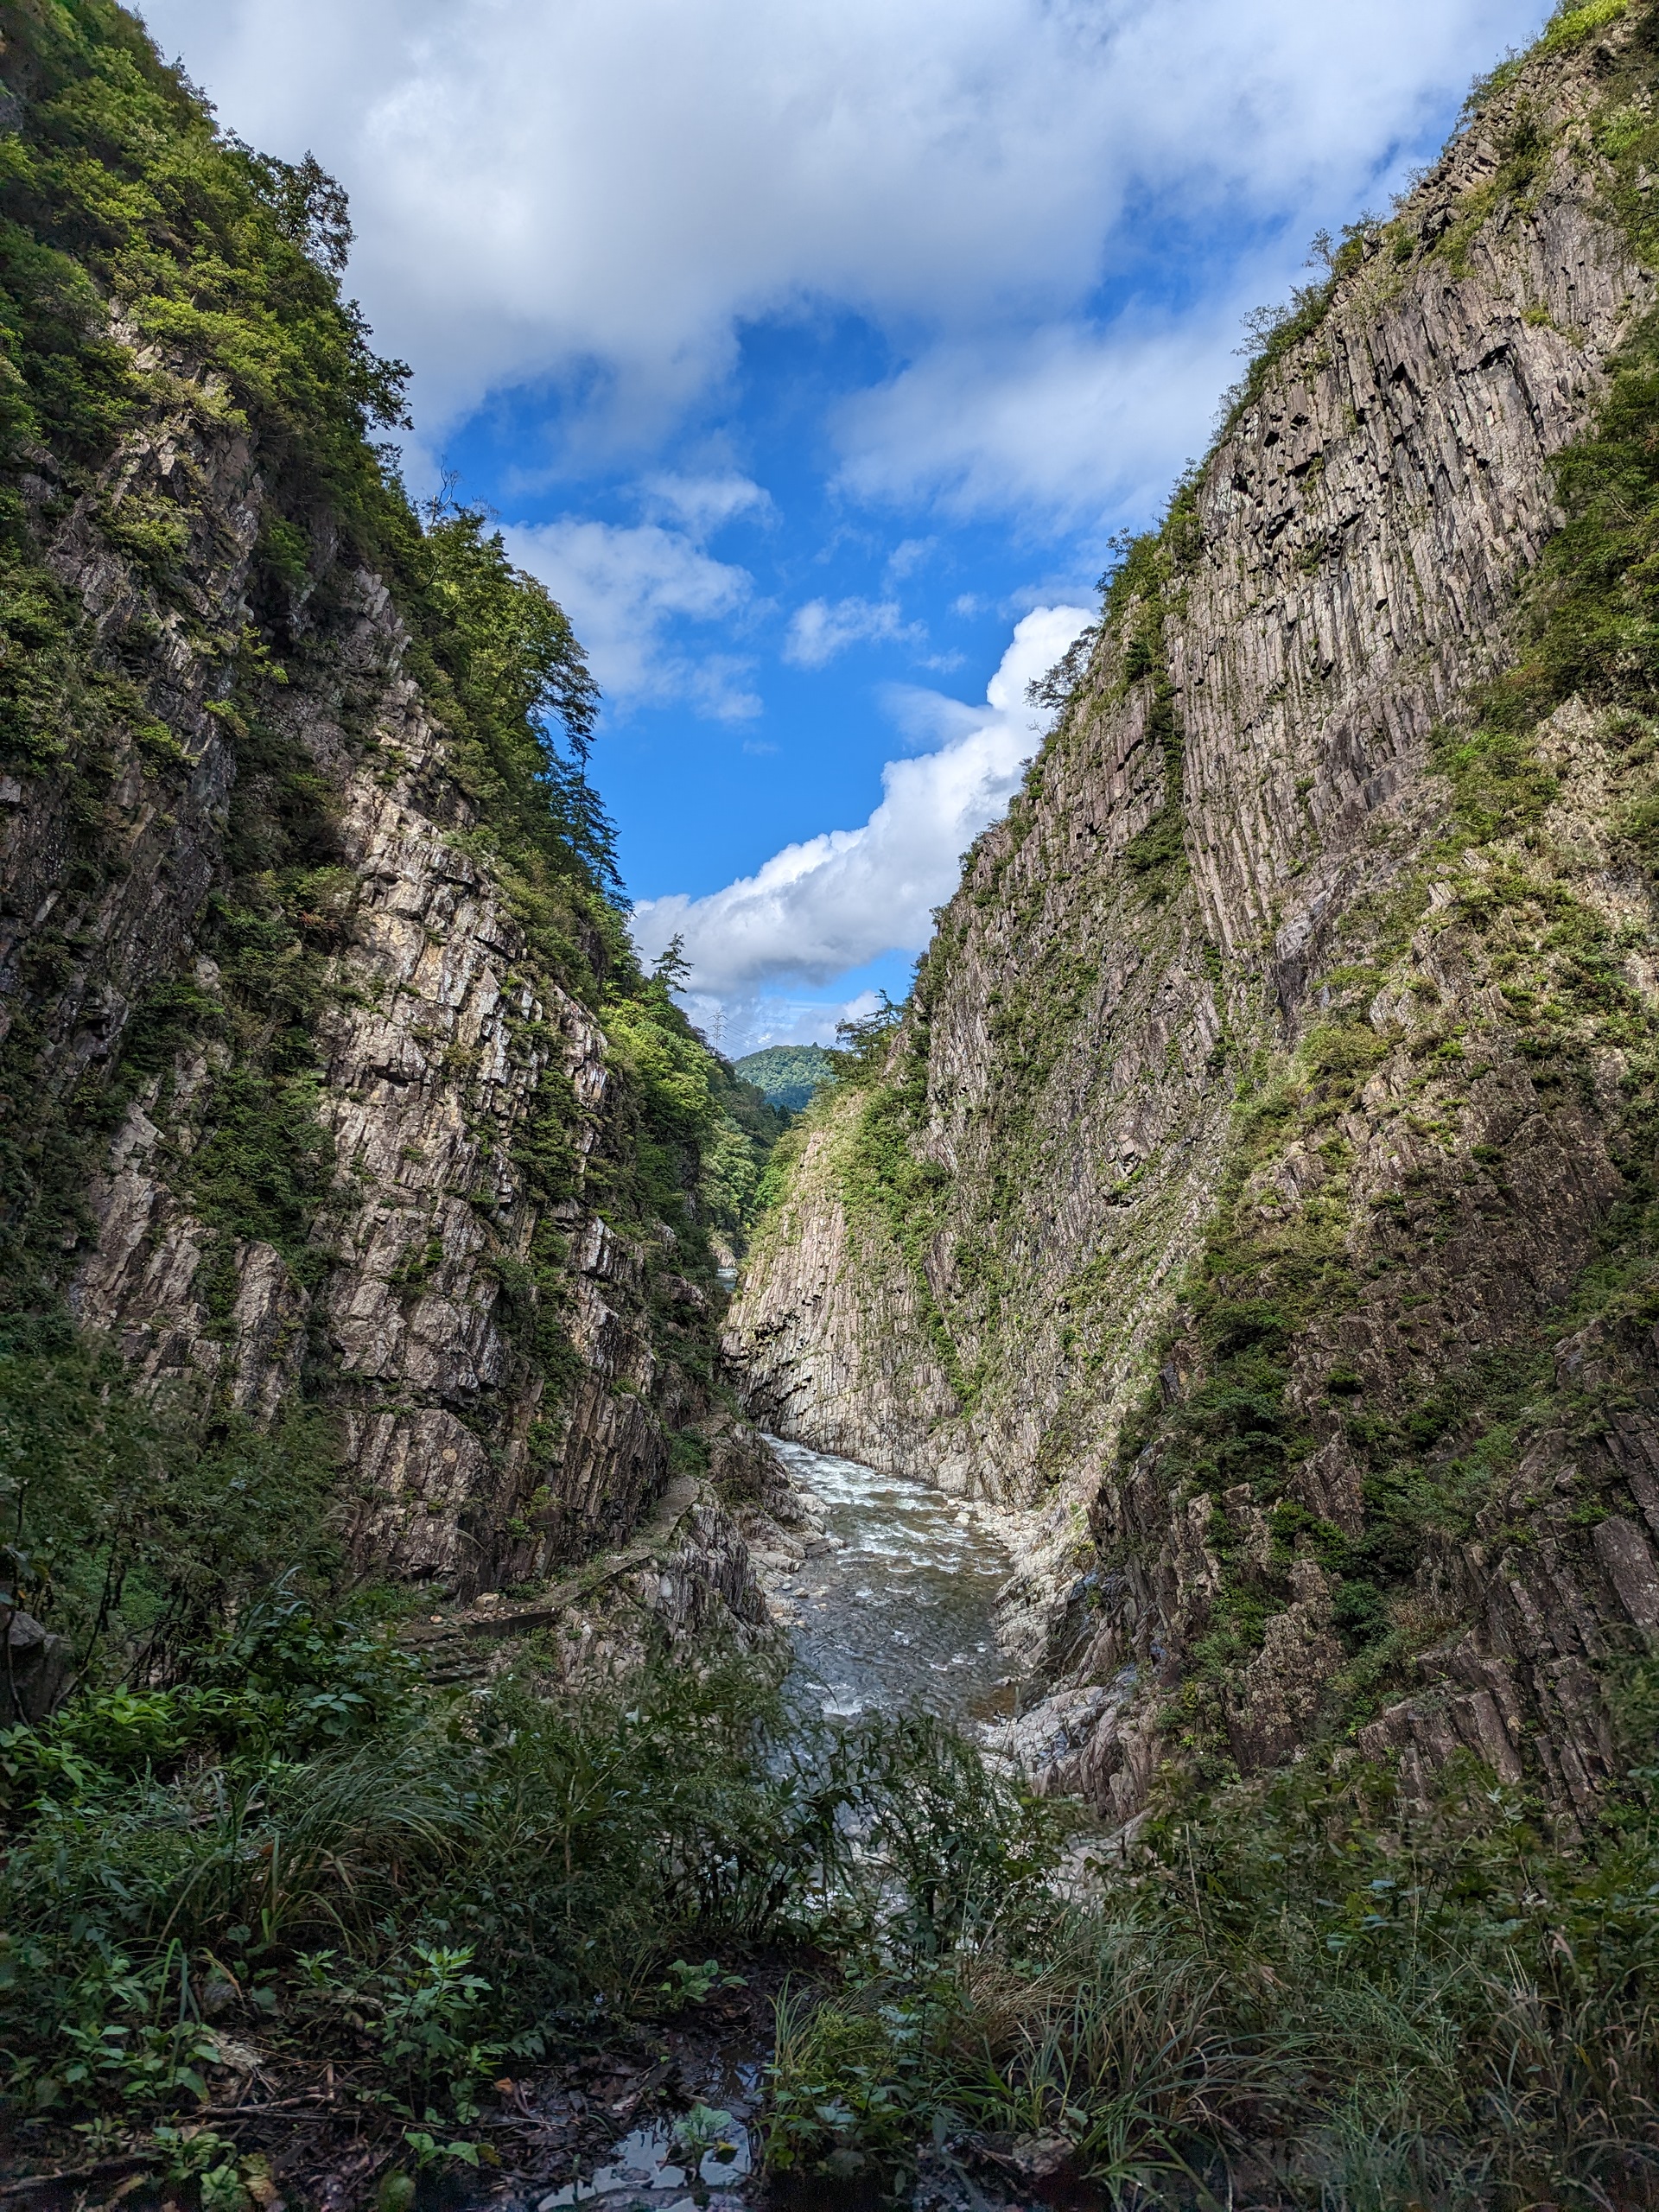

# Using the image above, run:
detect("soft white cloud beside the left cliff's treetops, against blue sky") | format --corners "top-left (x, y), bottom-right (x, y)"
top-left (502, 508), bottom-right (761, 721)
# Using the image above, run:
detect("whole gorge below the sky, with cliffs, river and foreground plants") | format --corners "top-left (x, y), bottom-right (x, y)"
top-left (0, 0), bottom-right (1659, 2212)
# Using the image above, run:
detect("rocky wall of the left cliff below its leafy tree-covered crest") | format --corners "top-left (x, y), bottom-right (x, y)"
top-left (0, 129), bottom-right (741, 1599)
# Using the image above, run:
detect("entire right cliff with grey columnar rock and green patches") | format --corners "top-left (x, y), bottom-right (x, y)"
top-left (732, 9), bottom-right (1659, 1816)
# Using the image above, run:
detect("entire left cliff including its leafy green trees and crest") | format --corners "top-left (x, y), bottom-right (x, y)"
top-left (0, 7), bottom-right (765, 1628)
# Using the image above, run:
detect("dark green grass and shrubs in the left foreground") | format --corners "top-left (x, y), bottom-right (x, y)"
top-left (0, 1599), bottom-right (1055, 2208)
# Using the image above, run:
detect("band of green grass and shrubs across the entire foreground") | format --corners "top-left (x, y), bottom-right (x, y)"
top-left (0, 1601), bottom-right (1659, 2212)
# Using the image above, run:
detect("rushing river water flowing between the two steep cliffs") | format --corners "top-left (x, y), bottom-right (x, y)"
top-left (767, 1435), bottom-right (1008, 1721)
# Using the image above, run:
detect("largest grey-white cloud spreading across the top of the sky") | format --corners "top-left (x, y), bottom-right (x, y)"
top-left (142, 0), bottom-right (1544, 480)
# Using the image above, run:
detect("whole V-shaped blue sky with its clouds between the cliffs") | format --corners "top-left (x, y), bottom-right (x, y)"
top-left (142, 0), bottom-right (1546, 1053)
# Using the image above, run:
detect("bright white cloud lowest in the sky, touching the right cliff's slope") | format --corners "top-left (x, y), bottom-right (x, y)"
top-left (632, 606), bottom-right (1090, 1000)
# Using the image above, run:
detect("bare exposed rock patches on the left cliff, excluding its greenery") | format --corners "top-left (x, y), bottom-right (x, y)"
top-left (35, 543), bottom-right (677, 1586)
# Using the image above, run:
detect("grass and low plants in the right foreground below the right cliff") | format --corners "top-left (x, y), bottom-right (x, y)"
top-left (770, 1767), bottom-right (1659, 2212)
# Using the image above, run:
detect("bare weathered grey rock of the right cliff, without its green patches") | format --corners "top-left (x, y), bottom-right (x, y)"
top-left (728, 31), bottom-right (1659, 1818)
